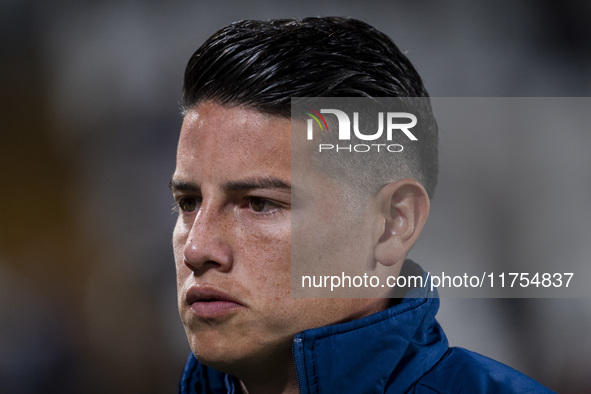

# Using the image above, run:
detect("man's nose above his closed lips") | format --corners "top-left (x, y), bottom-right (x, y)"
top-left (183, 207), bottom-right (233, 274)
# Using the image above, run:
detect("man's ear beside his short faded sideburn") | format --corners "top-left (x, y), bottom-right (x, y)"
top-left (375, 178), bottom-right (430, 266)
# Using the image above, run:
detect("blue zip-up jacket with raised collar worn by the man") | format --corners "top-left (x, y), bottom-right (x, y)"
top-left (179, 260), bottom-right (552, 394)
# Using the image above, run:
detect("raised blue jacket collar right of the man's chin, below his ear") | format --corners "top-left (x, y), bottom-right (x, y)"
top-left (293, 260), bottom-right (448, 393)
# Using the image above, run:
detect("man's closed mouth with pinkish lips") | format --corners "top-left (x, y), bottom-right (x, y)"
top-left (186, 286), bottom-right (244, 319)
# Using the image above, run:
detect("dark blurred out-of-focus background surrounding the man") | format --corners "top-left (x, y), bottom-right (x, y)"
top-left (0, 0), bottom-right (591, 393)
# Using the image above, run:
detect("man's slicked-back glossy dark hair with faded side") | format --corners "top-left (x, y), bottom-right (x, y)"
top-left (181, 17), bottom-right (438, 196)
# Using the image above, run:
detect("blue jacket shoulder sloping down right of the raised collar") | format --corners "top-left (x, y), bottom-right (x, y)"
top-left (413, 348), bottom-right (553, 393)
